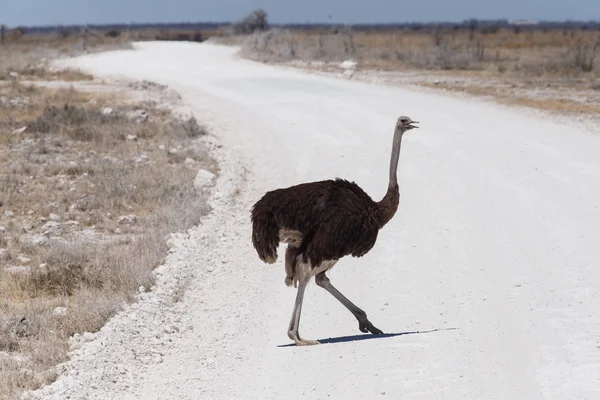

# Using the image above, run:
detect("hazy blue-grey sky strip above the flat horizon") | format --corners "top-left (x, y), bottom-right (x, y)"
top-left (0, 0), bottom-right (600, 27)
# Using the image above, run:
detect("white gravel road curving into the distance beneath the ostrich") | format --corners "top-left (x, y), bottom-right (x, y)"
top-left (25, 43), bottom-right (600, 400)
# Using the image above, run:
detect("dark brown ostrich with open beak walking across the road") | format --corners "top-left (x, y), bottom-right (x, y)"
top-left (251, 117), bottom-right (418, 346)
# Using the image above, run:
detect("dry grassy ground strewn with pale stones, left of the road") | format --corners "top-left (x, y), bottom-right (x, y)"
top-left (0, 32), bottom-right (217, 400)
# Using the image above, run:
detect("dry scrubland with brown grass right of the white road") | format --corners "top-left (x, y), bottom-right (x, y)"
top-left (233, 26), bottom-right (600, 113)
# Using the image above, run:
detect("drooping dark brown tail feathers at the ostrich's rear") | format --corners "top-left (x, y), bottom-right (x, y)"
top-left (252, 199), bottom-right (279, 264)
